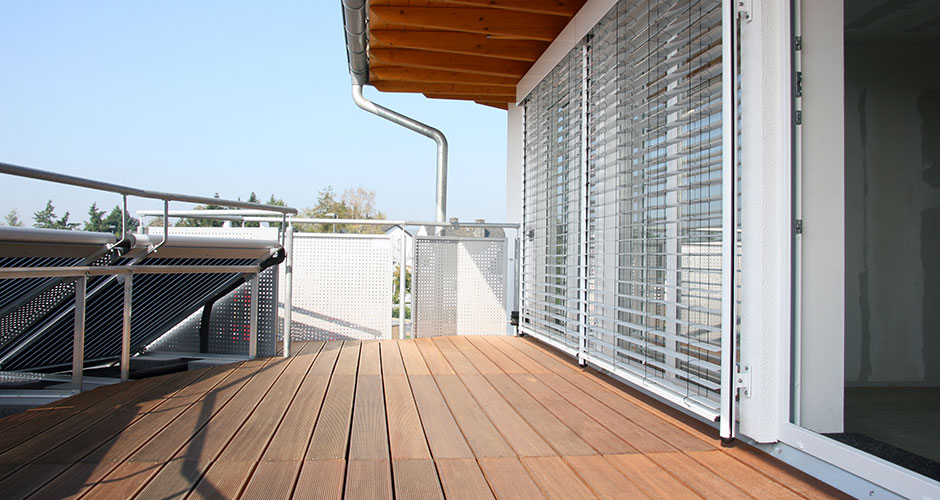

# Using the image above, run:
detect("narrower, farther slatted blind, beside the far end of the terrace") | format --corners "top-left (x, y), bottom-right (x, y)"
top-left (520, 48), bottom-right (583, 350)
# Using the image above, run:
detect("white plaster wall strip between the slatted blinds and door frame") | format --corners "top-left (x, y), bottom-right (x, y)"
top-left (739, 0), bottom-right (791, 442)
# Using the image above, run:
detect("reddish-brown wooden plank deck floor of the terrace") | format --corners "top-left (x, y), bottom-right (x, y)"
top-left (0, 337), bottom-right (842, 500)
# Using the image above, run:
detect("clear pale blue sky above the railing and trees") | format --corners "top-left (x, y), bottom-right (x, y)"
top-left (0, 0), bottom-right (506, 227)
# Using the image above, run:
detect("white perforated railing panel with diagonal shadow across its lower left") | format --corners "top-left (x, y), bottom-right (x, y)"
top-left (281, 233), bottom-right (392, 340)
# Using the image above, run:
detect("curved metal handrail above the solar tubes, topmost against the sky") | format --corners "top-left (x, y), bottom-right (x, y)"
top-left (0, 162), bottom-right (297, 215)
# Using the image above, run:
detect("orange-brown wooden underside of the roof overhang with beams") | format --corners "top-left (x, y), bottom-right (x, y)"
top-left (369, 0), bottom-right (585, 109)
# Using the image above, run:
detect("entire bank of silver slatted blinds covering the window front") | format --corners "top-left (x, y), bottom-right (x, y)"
top-left (520, 0), bottom-right (724, 418)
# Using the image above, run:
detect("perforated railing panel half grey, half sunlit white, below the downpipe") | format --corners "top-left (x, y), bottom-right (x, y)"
top-left (413, 236), bottom-right (506, 337)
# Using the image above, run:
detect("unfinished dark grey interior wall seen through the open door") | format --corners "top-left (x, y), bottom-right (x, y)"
top-left (845, 41), bottom-right (940, 386)
